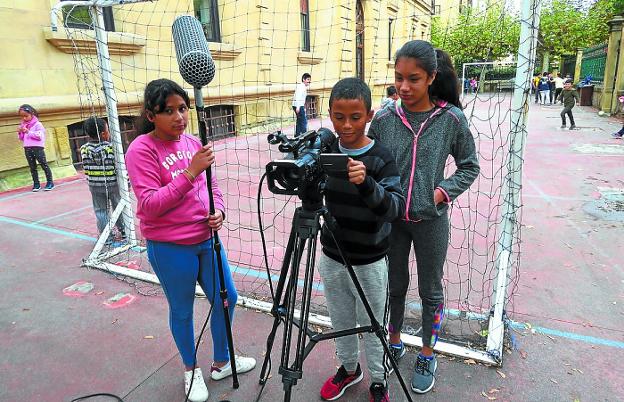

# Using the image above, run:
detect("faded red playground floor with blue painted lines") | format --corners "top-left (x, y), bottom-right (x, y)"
top-left (0, 98), bottom-right (624, 402)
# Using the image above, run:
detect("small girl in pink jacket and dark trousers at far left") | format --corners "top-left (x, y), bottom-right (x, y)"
top-left (17, 104), bottom-right (54, 192)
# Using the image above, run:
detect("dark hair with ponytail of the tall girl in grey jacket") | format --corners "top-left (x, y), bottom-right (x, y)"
top-left (394, 40), bottom-right (462, 109)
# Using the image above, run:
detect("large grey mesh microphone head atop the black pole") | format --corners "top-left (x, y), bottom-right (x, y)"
top-left (172, 15), bottom-right (215, 88)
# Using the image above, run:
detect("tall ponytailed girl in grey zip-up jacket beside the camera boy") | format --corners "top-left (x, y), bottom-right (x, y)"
top-left (369, 40), bottom-right (479, 393)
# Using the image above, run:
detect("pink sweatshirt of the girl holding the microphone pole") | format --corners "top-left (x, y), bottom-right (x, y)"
top-left (126, 134), bottom-right (225, 245)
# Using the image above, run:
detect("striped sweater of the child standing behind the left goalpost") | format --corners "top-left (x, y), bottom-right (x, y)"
top-left (80, 141), bottom-right (117, 190)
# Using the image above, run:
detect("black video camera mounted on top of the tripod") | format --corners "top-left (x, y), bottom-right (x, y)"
top-left (266, 128), bottom-right (348, 201)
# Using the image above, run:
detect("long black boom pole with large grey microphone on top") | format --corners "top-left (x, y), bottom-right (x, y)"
top-left (172, 15), bottom-right (239, 388)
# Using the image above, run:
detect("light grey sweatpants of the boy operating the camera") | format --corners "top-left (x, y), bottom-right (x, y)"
top-left (318, 254), bottom-right (388, 383)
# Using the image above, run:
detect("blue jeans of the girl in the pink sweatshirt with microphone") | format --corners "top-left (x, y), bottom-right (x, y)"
top-left (147, 239), bottom-right (238, 366)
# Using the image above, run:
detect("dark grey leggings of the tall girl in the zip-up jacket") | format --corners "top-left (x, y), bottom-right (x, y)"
top-left (388, 214), bottom-right (449, 347)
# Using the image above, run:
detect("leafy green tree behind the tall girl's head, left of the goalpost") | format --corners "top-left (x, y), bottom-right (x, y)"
top-left (431, 5), bottom-right (520, 69)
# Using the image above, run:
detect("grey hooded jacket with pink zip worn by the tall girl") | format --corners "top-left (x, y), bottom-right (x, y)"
top-left (368, 100), bottom-right (479, 221)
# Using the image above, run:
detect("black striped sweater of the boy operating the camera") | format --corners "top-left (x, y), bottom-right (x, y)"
top-left (321, 141), bottom-right (405, 265)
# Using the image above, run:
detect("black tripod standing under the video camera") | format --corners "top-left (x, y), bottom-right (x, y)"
top-left (260, 200), bottom-right (412, 402)
